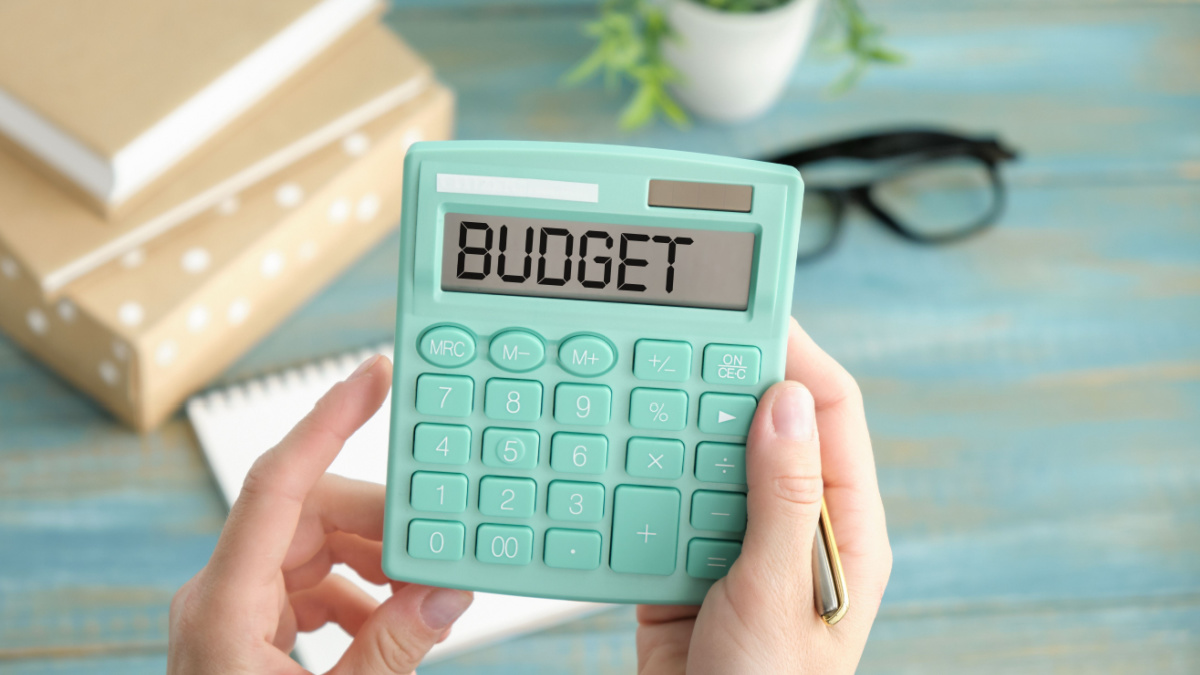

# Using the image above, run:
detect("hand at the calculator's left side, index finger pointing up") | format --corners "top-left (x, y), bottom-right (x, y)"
top-left (167, 357), bottom-right (472, 675)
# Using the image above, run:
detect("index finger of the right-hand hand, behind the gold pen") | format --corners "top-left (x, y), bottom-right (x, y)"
top-left (787, 319), bottom-right (892, 598)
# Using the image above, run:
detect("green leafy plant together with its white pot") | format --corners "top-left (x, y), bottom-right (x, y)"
top-left (565, 0), bottom-right (902, 129)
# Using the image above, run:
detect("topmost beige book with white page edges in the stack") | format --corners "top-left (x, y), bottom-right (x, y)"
top-left (0, 0), bottom-right (377, 205)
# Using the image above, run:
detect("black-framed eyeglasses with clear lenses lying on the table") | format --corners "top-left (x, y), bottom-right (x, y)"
top-left (768, 129), bottom-right (1016, 261)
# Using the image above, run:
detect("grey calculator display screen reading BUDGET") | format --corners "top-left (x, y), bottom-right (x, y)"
top-left (442, 214), bottom-right (755, 310)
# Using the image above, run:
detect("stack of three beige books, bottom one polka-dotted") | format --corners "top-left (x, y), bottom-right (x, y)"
top-left (0, 0), bottom-right (454, 430)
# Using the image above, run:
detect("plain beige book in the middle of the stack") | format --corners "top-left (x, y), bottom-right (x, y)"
top-left (0, 25), bottom-right (432, 297)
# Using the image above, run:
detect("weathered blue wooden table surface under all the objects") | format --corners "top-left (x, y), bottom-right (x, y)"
top-left (0, 0), bottom-right (1200, 675)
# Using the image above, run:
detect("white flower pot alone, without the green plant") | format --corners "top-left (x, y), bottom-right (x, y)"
top-left (662, 0), bottom-right (820, 121)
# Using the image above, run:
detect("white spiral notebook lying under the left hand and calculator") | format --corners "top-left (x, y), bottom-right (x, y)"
top-left (187, 345), bottom-right (608, 673)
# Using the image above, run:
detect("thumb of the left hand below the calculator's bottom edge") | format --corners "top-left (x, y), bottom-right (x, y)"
top-left (330, 584), bottom-right (474, 675)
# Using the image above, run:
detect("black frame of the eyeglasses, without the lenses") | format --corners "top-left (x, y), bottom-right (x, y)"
top-left (769, 129), bottom-right (1018, 262)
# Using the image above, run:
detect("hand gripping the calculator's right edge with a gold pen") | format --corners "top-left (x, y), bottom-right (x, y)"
top-left (637, 321), bottom-right (892, 675)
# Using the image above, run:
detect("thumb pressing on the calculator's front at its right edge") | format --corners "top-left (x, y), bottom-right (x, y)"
top-left (730, 382), bottom-right (823, 595)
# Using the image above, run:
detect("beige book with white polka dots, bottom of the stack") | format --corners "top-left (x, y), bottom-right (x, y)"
top-left (0, 84), bottom-right (454, 429)
